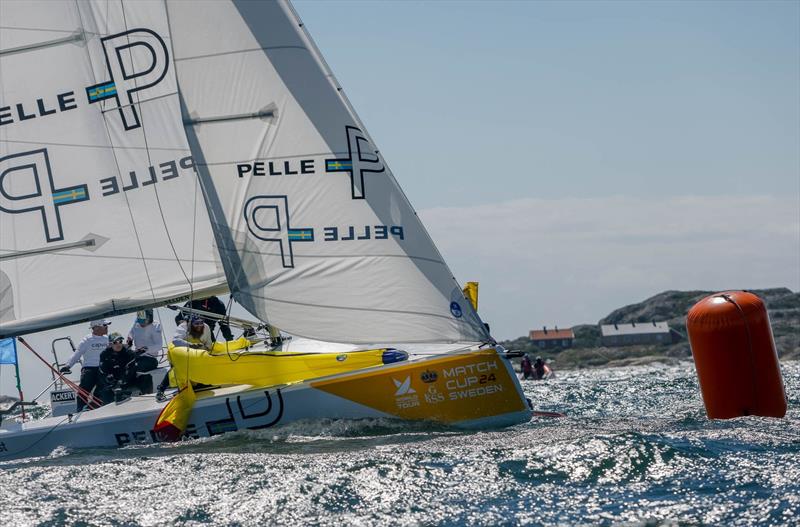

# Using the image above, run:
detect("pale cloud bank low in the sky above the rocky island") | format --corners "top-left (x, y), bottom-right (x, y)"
top-left (420, 196), bottom-right (800, 338)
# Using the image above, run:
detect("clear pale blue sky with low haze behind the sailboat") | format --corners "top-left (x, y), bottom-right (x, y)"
top-left (0, 0), bottom-right (800, 395)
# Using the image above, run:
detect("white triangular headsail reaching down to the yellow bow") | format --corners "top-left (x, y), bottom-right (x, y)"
top-left (167, 1), bottom-right (488, 343)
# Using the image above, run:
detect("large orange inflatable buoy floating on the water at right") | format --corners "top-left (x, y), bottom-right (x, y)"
top-left (686, 291), bottom-right (786, 419)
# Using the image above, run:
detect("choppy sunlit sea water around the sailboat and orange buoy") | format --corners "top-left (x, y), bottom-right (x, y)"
top-left (0, 363), bottom-right (800, 526)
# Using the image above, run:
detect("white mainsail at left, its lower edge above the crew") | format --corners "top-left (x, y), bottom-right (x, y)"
top-left (0, 0), bottom-right (226, 336)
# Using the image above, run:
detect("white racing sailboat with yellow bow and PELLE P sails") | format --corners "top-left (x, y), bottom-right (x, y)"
top-left (0, 0), bottom-right (531, 458)
